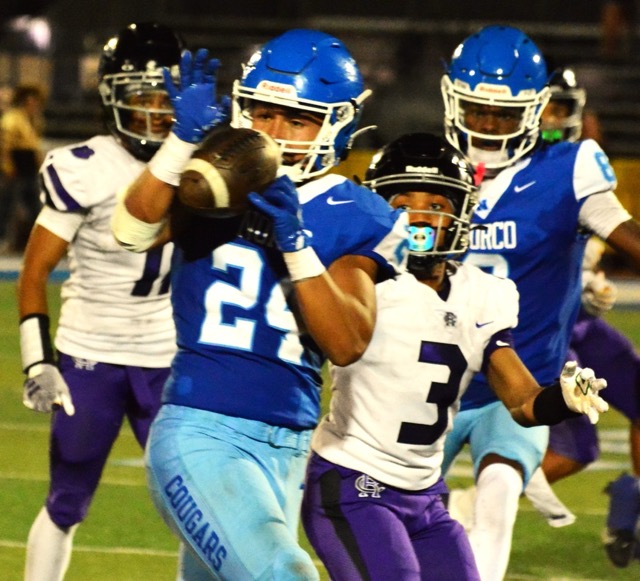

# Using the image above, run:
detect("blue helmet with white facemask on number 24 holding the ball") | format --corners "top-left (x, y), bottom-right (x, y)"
top-left (231, 29), bottom-right (371, 182)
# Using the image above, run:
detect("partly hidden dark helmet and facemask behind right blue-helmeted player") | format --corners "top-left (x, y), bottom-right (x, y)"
top-left (540, 67), bottom-right (587, 143)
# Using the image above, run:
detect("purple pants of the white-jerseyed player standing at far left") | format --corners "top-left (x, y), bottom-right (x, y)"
top-left (46, 353), bottom-right (169, 528)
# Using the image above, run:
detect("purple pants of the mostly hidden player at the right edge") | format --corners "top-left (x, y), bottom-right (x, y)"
top-left (549, 312), bottom-right (640, 464)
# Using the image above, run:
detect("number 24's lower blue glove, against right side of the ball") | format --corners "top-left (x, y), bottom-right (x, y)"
top-left (249, 176), bottom-right (308, 252)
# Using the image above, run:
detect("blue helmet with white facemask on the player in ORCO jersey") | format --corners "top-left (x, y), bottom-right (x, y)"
top-left (441, 26), bottom-right (549, 170)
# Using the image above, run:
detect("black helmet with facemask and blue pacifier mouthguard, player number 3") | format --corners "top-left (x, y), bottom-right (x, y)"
top-left (363, 133), bottom-right (477, 278)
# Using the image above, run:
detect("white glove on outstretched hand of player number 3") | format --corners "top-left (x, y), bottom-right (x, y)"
top-left (560, 361), bottom-right (609, 424)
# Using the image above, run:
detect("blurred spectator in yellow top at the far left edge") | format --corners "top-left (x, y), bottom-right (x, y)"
top-left (0, 85), bottom-right (45, 252)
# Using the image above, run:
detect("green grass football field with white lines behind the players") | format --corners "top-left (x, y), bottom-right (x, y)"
top-left (0, 282), bottom-right (640, 581)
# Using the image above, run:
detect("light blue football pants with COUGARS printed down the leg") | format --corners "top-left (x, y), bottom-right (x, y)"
top-left (146, 404), bottom-right (319, 581)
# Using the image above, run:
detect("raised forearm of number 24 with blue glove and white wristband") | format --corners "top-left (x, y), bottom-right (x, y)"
top-left (112, 49), bottom-right (229, 252)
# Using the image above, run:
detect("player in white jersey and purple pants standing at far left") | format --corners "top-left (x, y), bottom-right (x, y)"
top-left (18, 23), bottom-right (182, 581)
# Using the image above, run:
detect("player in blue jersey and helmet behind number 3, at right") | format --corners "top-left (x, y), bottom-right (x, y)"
top-left (442, 26), bottom-right (640, 580)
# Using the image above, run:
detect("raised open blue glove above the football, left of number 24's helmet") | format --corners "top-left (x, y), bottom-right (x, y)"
top-left (163, 48), bottom-right (231, 143)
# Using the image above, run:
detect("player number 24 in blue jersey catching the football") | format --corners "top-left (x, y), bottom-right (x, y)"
top-left (113, 29), bottom-right (407, 580)
